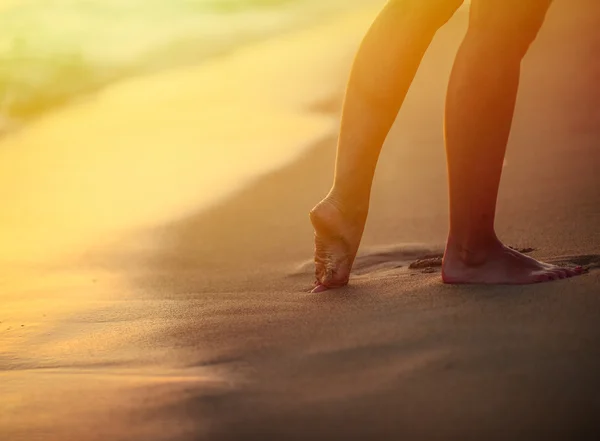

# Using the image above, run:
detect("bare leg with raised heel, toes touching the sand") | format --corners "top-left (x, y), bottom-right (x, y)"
top-left (311, 0), bottom-right (463, 292)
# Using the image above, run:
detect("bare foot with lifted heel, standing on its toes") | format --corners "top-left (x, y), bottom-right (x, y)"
top-left (310, 197), bottom-right (367, 293)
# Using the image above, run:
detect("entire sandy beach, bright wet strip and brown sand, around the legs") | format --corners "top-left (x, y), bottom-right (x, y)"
top-left (0, 0), bottom-right (600, 441)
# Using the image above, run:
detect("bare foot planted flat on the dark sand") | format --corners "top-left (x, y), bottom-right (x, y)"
top-left (442, 239), bottom-right (585, 285)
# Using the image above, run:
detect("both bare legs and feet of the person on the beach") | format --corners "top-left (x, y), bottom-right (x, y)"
top-left (310, 0), bottom-right (583, 292)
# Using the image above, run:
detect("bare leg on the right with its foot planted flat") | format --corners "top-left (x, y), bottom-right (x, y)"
top-left (442, 0), bottom-right (581, 284)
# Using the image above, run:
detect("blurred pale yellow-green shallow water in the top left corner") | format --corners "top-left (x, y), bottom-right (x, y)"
top-left (0, 0), bottom-right (370, 131)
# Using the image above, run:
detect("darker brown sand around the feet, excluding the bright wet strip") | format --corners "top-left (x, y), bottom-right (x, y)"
top-left (0, 0), bottom-right (600, 441)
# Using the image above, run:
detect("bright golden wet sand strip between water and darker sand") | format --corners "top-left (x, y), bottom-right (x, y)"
top-left (0, 8), bottom-right (373, 268)
